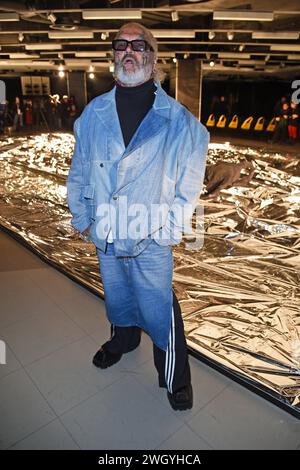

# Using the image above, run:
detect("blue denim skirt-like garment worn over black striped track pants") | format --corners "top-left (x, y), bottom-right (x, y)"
top-left (97, 240), bottom-right (173, 351)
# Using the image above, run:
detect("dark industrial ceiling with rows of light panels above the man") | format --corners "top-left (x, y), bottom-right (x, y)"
top-left (0, 0), bottom-right (300, 79)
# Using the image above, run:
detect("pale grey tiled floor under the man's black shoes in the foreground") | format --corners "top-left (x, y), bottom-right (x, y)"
top-left (0, 232), bottom-right (300, 450)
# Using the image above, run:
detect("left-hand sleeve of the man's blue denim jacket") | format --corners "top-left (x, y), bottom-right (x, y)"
top-left (67, 119), bottom-right (90, 232)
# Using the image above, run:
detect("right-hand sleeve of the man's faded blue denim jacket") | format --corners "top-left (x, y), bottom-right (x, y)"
top-left (159, 116), bottom-right (209, 245)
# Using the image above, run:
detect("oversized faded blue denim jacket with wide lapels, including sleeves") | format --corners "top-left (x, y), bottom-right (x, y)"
top-left (67, 82), bottom-right (209, 256)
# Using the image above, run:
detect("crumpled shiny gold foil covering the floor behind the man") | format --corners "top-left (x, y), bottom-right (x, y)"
top-left (0, 133), bottom-right (300, 417)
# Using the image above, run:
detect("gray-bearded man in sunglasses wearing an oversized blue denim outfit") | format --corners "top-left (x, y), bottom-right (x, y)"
top-left (67, 23), bottom-right (208, 410)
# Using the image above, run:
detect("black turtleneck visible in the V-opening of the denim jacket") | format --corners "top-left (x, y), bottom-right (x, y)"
top-left (116, 79), bottom-right (156, 147)
